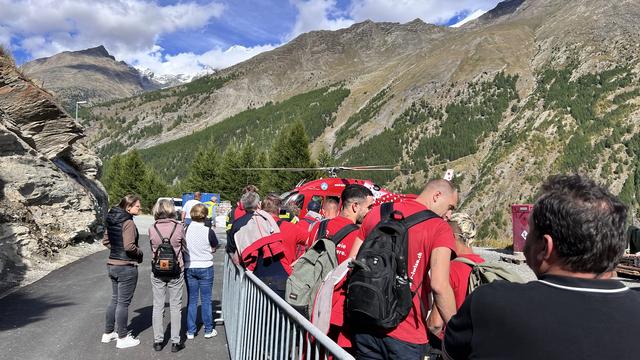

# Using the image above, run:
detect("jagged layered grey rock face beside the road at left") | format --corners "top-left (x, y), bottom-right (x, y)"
top-left (0, 50), bottom-right (107, 292)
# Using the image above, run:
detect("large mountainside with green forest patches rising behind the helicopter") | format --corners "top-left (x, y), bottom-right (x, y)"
top-left (84, 0), bottom-right (640, 245)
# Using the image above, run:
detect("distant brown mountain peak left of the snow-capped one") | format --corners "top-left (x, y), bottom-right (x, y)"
top-left (20, 46), bottom-right (161, 108)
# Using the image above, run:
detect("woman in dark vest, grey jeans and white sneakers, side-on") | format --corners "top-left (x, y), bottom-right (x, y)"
top-left (102, 195), bottom-right (142, 349)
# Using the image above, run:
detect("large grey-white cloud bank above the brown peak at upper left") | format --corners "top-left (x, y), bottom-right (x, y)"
top-left (0, 0), bottom-right (224, 57)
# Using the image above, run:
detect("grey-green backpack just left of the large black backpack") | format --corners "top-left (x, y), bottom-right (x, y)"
top-left (284, 220), bottom-right (358, 319)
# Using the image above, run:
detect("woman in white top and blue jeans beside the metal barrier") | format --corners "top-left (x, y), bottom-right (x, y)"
top-left (184, 204), bottom-right (218, 340)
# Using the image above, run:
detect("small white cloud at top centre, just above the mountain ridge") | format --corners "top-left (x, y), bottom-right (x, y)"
top-left (286, 0), bottom-right (354, 40)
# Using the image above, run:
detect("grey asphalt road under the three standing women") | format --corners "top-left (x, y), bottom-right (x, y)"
top-left (0, 229), bottom-right (229, 360)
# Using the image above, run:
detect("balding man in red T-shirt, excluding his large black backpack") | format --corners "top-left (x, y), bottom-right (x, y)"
top-left (351, 179), bottom-right (458, 360)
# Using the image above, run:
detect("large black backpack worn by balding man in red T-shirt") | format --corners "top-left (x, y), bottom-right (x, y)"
top-left (346, 203), bottom-right (438, 329)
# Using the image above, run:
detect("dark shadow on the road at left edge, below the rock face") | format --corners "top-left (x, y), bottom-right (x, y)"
top-left (0, 292), bottom-right (75, 331)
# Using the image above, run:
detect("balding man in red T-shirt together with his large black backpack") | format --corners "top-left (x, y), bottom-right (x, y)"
top-left (345, 179), bottom-right (458, 360)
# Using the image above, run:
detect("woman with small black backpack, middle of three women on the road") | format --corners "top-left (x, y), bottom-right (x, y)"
top-left (148, 200), bottom-right (185, 352)
